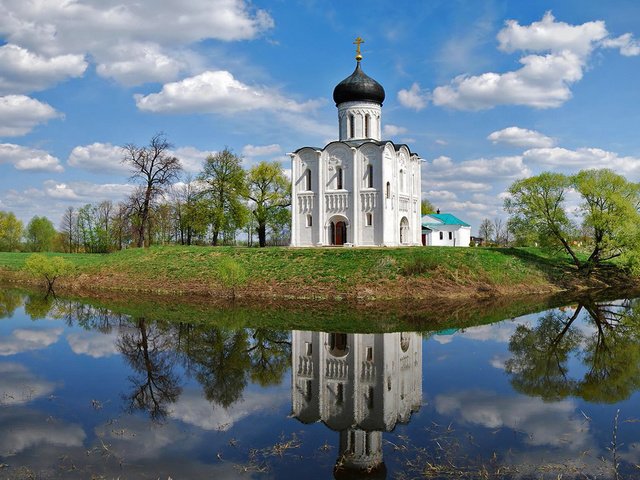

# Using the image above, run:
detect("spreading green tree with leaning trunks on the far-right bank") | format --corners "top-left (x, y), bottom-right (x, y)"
top-left (505, 169), bottom-right (640, 274)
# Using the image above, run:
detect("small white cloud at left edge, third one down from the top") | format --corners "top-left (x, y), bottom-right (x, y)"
top-left (0, 95), bottom-right (61, 137)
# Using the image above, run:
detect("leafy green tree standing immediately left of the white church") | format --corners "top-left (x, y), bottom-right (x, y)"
top-left (245, 161), bottom-right (291, 247)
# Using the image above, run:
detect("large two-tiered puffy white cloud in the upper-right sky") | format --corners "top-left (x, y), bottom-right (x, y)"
top-left (433, 12), bottom-right (640, 110)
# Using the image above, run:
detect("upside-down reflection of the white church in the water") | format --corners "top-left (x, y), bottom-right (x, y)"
top-left (291, 330), bottom-right (422, 478)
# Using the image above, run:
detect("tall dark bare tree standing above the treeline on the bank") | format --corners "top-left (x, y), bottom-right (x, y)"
top-left (122, 133), bottom-right (182, 247)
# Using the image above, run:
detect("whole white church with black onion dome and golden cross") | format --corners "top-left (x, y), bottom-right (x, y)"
top-left (291, 38), bottom-right (422, 247)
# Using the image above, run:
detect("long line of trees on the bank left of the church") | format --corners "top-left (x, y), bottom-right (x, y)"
top-left (0, 134), bottom-right (291, 253)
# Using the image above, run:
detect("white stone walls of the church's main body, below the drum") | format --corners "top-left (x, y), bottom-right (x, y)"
top-left (291, 142), bottom-right (422, 246)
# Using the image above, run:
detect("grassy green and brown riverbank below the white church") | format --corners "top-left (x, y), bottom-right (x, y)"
top-left (0, 246), bottom-right (638, 303)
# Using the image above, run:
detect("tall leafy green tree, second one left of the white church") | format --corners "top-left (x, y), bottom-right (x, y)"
top-left (198, 147), bottom-right (247, 246)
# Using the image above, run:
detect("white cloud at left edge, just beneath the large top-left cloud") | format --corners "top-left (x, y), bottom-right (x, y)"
top-left (0, 44), bottom-right (87, 94)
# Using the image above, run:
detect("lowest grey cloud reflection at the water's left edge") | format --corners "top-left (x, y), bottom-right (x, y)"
top-left (0, 409), bottom-right (85, 455)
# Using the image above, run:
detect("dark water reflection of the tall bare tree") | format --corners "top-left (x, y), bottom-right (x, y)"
top-left (118, 318), bottom-right (182, 420)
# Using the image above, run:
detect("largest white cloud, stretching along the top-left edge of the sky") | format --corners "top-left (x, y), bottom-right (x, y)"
top-left (0, 0), bottom-right (274, 85)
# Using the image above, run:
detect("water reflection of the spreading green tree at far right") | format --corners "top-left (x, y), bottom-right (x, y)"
top-left (505, 300), bottom-right (640, 402)
